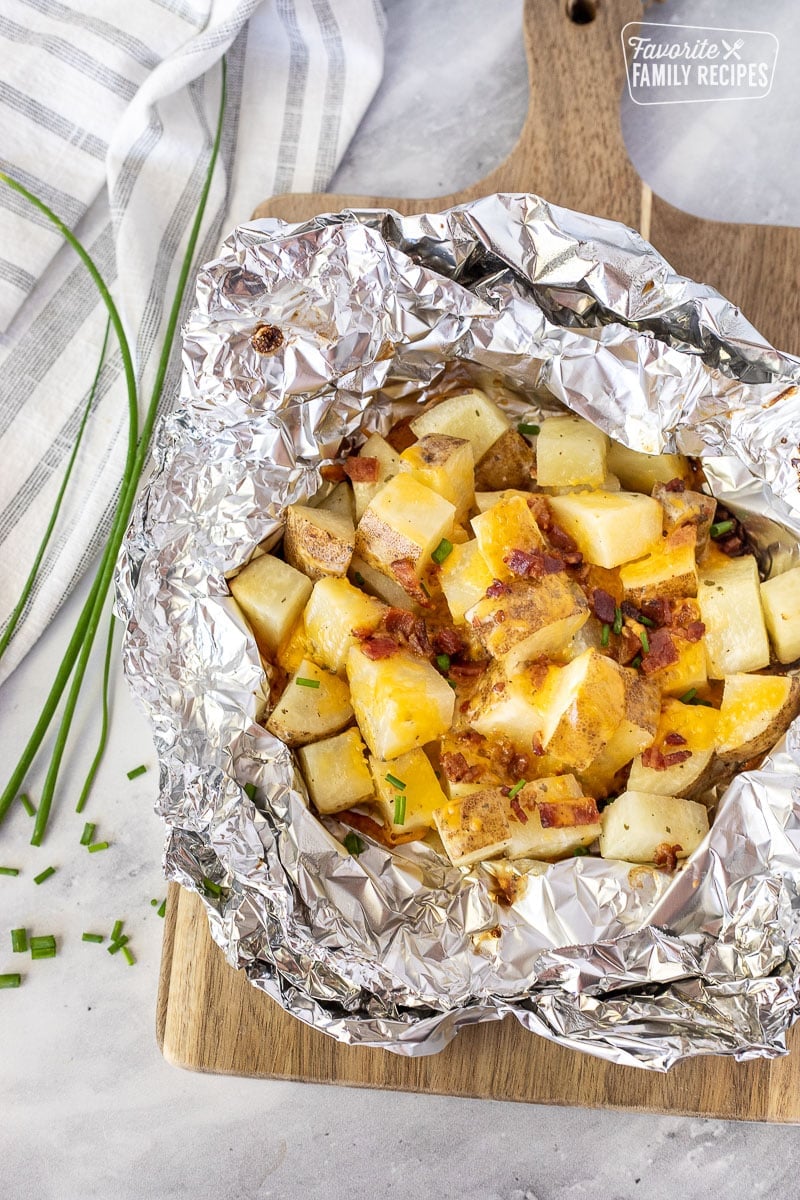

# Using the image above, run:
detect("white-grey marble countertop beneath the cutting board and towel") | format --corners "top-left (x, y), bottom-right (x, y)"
top-left (0, 0), bottom-right (800, 1200)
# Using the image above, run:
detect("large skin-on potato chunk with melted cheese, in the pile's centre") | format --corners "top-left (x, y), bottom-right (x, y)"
top-left (467, 572), bottom-right (589, 674)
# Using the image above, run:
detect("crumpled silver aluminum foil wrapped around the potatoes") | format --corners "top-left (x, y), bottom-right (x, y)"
top-left (116, 194), bottom-right (800, 1070)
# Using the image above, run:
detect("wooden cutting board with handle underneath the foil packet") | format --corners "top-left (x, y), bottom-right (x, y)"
top-left (157, 0), bottom-right (800, 1122)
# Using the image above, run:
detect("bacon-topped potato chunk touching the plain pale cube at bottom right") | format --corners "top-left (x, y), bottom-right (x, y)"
top-left (506, 775), bottom-right (601, 859)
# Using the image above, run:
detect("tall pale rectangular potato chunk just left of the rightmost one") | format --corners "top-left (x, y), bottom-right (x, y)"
top-left (697, 554), bottom-right (770, 679)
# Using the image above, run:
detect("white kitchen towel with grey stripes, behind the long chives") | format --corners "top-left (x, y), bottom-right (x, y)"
top-left (0, 0), bottom-right (384, 680)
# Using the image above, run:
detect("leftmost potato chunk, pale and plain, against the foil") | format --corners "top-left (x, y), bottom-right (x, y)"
top-left (228, 554), bottom-right (311, 658)
